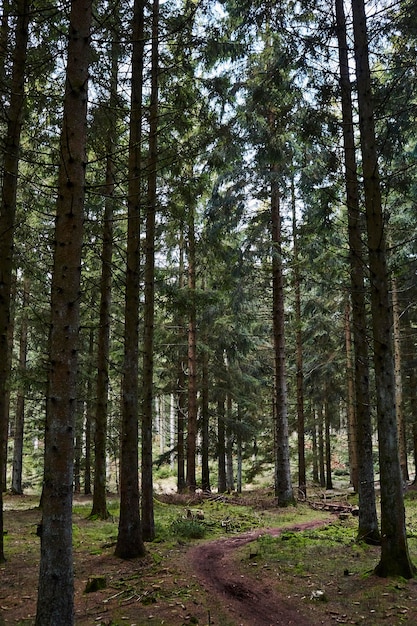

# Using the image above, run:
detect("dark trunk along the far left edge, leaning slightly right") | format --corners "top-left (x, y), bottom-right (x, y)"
top-left (0, 0), bottom-right (30, 562)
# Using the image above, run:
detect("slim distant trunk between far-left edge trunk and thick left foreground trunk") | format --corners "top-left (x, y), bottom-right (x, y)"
top-left (12, 276), bottom-right (30, 494)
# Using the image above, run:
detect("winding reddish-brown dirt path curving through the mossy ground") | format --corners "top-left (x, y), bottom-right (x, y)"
top-left (190, 521), bottom-right (327, 626)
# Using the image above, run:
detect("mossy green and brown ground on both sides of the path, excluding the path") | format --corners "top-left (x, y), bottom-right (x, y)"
top-left (1, 492), bottom-right (417, 626)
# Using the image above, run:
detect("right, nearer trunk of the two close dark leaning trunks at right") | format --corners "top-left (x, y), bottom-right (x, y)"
top-left (352, 0), bottom-right (414, 578)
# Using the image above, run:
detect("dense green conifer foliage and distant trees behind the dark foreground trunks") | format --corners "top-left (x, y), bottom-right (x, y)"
top-left (2, 2), bottom-right (416, 492)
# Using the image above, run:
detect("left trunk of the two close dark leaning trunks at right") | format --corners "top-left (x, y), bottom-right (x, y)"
top-left (336, 0), bottom-right (380, 543)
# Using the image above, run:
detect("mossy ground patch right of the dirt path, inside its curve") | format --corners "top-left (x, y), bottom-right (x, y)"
top-left (238, 498), bottom-right (417, 626)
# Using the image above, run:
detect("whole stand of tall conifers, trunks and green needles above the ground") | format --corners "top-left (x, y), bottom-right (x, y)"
top-left (0, 0), bottom-right (417, 626)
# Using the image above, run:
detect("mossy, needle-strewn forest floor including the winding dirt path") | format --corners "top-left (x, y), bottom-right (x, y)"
top-left (0, 495), bottom-right (417, 626)
